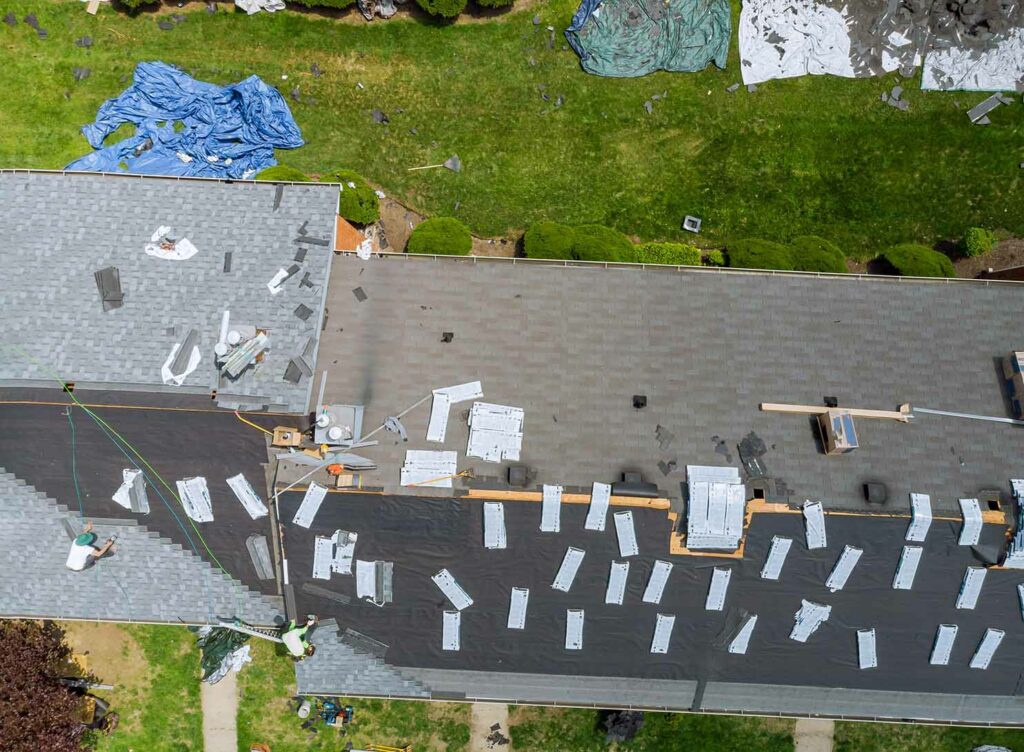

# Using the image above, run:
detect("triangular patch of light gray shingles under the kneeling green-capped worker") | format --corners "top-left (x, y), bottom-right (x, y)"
top-left (0, 468), bottom-right (280, 625)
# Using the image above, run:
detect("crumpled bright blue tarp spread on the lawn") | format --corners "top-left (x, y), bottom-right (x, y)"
top-left (66, 62), bottom-right (303, 178)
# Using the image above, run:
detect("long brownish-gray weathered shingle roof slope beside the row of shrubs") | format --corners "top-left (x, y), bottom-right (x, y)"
top-left (321, 255), bottom-right (1024, 514)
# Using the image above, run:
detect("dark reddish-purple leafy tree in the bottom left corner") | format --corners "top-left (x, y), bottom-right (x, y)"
top-left (0, 621), bottom-right (83, 752)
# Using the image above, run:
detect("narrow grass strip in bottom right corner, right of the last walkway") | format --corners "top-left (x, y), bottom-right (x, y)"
top-left (835, 723), bottom-right (1024, 752)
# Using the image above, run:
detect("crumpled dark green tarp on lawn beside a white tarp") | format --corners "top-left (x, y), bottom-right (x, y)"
top-left (565, 0), bottom-right (731, 78)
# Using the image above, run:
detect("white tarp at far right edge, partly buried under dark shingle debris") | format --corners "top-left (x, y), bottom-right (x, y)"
top-left (921, 29), bottom-right (1024, 91)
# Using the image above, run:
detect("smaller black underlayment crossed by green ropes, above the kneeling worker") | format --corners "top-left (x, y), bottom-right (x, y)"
top-left (0, 389), bottom-right (276, 594)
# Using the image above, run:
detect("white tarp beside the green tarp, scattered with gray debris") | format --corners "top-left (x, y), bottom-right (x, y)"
top-left (739, 0), bottom-right (907, 85)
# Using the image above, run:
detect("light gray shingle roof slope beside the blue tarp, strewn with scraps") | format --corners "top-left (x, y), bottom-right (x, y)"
top-left (0, 172), bottom-right (338, 412)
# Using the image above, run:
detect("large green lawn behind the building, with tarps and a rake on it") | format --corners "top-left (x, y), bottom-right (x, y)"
top-left (0, 0), bottom-right (1024, 258)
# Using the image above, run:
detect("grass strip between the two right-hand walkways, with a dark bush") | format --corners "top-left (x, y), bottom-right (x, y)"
top-left (509, 708), bottom-right (794, 752)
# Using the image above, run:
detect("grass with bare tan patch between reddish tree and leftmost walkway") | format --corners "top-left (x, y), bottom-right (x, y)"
top-left (62, 623), bottom-right (203, 752)
